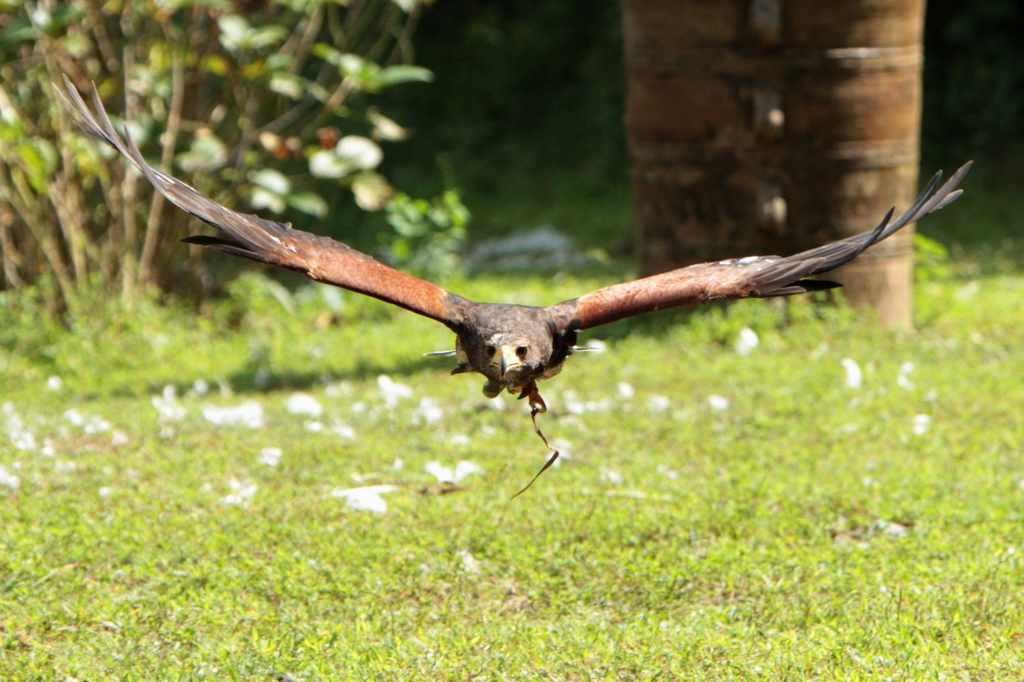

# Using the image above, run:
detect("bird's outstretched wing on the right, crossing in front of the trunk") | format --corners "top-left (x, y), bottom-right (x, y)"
top-left (552, 162), bottom-right (971, 331)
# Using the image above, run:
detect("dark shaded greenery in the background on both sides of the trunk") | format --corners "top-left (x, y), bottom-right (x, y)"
top-left (385, 0), bottom-right (1024, 248)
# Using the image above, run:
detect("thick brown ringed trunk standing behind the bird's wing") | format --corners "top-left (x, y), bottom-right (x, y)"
top-left (623, 0), bottom-right (925, 327)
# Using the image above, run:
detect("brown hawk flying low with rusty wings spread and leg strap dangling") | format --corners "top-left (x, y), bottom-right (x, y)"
top-left (57, 76), bottom-right (971, 493)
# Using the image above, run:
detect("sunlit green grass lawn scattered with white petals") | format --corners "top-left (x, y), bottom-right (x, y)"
top-left (0, 274), bottom-right (1024, 682)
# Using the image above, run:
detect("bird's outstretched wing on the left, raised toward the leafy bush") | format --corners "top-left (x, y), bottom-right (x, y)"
top-left (56, 76), bottom-right (469, 330)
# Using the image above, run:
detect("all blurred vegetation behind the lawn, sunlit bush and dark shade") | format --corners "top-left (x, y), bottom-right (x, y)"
top-left (0, 0), bottom-right (1024, 312)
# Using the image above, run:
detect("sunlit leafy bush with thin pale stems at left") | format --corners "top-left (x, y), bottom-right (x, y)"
top-left (0, 0), bottom-right (466, 311)
